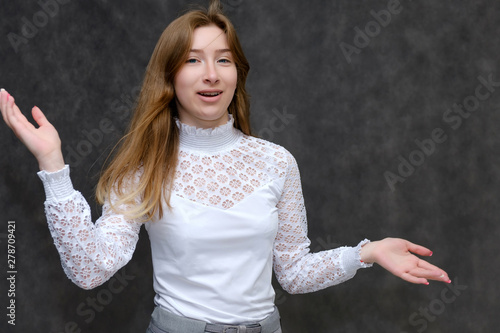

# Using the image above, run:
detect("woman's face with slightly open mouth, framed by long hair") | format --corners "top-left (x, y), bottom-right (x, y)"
top-left (174, 25), bottom-right (237, 128)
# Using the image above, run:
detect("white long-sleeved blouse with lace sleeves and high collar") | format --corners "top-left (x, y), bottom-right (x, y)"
top-left (38, 116), bottom-right (371, 323)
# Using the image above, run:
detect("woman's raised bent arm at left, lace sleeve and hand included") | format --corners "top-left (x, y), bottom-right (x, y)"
top-left (0, 89), bottom-right (141, 289)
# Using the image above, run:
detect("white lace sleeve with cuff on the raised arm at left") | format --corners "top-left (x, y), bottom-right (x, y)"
top-left (38, 166), bottom-right (142, 289)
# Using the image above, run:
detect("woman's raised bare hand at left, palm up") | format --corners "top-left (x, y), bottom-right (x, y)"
top-left (0, 89), bottom-right (64, 172)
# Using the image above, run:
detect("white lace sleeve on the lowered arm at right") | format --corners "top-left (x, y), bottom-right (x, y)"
top-left (274, 154), bottom-right (371, 294)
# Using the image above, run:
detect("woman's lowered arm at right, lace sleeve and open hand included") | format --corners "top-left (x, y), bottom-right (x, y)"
top-left (274, 150), bottom-right (450, 293)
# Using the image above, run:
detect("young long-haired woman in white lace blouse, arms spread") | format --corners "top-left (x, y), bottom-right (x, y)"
top-left (0, 1), bottom-right (450, 333)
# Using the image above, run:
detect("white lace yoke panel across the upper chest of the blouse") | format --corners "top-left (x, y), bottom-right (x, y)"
top-left (173, 137), bottom-right (287, 209)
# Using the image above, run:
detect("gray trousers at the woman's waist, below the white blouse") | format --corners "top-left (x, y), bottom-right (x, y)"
top-left (146, 306), bottom-right (282, 333)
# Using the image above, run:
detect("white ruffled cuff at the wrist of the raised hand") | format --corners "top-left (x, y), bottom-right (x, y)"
top-left (37, 164), bottom-right (75, 201)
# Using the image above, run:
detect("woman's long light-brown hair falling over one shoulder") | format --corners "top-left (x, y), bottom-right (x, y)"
top-left (96, 0), bottom-right (251, 220)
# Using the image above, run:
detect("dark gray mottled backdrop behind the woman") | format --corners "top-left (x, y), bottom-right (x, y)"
top-left (0, 0), bottom-right (500, 333)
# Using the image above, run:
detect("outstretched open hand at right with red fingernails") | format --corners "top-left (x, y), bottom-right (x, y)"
top-left (361, 238), bottom-right (451, 284)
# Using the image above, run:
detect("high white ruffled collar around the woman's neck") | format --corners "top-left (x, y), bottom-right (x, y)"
top-left (176, 114), bottom-right (241, 153)
